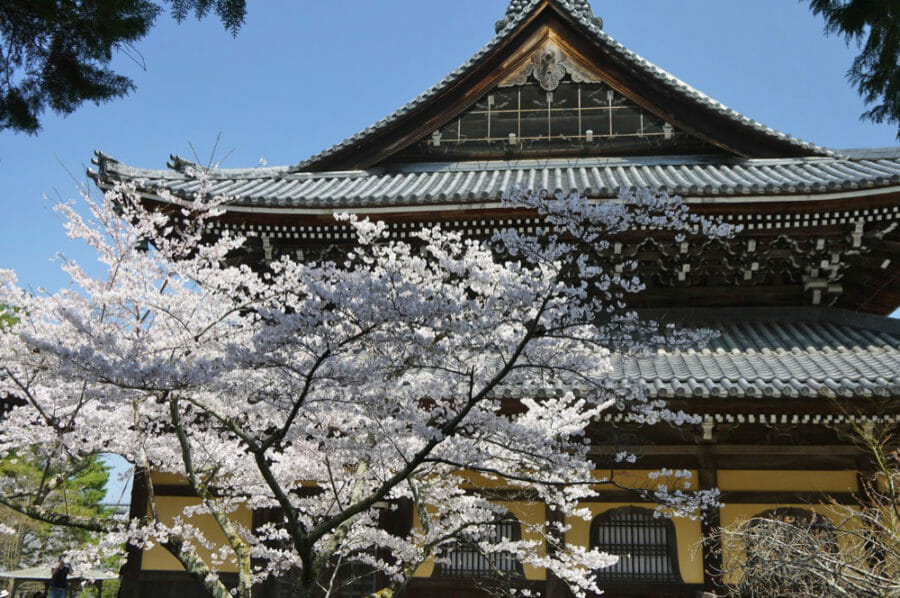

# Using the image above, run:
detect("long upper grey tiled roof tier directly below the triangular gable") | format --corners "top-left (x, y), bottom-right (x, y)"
top-left (95, 149), bottom-right (900, 209)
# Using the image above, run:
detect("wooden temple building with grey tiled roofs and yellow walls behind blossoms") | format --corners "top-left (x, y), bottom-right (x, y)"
top-left (93, 0), bottom-right (900, 598)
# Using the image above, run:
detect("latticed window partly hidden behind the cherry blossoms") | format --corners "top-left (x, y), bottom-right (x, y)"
top-left (436, 520), bottom-right (522, 577)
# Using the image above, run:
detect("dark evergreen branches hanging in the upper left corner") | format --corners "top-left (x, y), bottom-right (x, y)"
top-left (0, 0), bottom-right (246, 133)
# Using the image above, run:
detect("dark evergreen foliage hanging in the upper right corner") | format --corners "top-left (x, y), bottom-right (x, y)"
top-left (809, 0), bottom-right (900, 139)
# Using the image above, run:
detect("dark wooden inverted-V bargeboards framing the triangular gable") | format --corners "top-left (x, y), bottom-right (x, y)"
top-left (298, 0), bottom-right (821, 172)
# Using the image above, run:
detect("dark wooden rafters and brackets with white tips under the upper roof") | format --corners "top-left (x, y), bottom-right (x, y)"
top-left (123, 191), bottom-right (900, 313)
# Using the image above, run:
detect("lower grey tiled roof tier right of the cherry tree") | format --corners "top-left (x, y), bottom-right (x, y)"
top-left (496, 309), bottom-right (900, 399)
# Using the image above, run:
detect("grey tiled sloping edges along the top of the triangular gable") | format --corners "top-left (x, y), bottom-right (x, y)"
top-left (294, 0), bottom-right (834, 170)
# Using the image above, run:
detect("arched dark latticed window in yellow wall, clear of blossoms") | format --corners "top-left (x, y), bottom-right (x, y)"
top-left (591, 507), bottom-right (680, 582)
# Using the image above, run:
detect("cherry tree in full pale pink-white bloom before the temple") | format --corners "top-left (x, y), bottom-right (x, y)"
top-left (0, 186), bottom-right (733, 598)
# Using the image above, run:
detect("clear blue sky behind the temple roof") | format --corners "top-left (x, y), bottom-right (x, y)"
top-left (0, 0), bottom-right (896, 506)
